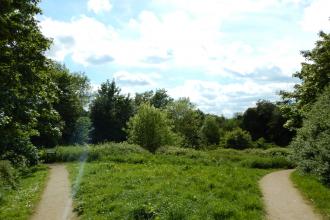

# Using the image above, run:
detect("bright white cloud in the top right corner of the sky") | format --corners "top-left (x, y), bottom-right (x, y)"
top-left (301, 0), bottom-right (330, 32)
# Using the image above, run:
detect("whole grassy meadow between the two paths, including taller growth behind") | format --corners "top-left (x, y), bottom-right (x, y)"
top-left (46, 143), bottom-right (292, 219)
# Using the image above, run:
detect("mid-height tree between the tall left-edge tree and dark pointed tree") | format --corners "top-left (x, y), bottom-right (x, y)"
top-left (32, 62), bottom-right (90, 147)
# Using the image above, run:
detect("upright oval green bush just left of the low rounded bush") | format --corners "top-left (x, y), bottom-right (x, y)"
top-left (200, 115), bottom-right (220, 145)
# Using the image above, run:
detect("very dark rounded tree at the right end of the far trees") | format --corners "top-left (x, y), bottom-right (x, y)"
top-left (242, 100), bottom-right (293, 146)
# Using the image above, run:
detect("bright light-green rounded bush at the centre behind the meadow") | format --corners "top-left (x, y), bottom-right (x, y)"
top-left (127, 104), bottom-right (175, 152)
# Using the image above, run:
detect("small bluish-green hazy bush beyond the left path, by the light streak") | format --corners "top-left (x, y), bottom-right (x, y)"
top-left (71, 116), bottom-right (92, 144)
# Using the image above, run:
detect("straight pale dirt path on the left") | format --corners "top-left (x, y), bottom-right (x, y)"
top-left (31, 164), bottom-right (76, 220)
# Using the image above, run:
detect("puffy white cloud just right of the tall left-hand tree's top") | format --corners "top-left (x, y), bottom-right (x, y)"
top-left (40, 16), bottom-right (118, 65)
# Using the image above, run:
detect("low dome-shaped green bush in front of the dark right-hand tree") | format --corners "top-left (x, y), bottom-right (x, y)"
top-left (224, 128), bottom-right (252, 150)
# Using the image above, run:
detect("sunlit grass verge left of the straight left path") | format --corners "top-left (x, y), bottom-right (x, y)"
top-left (0, 166), bottom-right (48, 220)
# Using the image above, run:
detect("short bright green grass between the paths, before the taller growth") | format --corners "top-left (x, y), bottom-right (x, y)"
top-left (69, 162), bottom-right (266, 219)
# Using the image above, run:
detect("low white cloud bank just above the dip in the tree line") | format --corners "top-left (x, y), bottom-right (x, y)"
top-left (169, 80), bottom-right (293, 116)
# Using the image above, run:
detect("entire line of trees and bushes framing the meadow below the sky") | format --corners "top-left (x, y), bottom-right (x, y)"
top-left (0, 0), bottom-right (330, 182)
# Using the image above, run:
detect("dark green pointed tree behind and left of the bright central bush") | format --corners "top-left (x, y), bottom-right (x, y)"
top-left (90, 81), bottom-right (133, 143)
